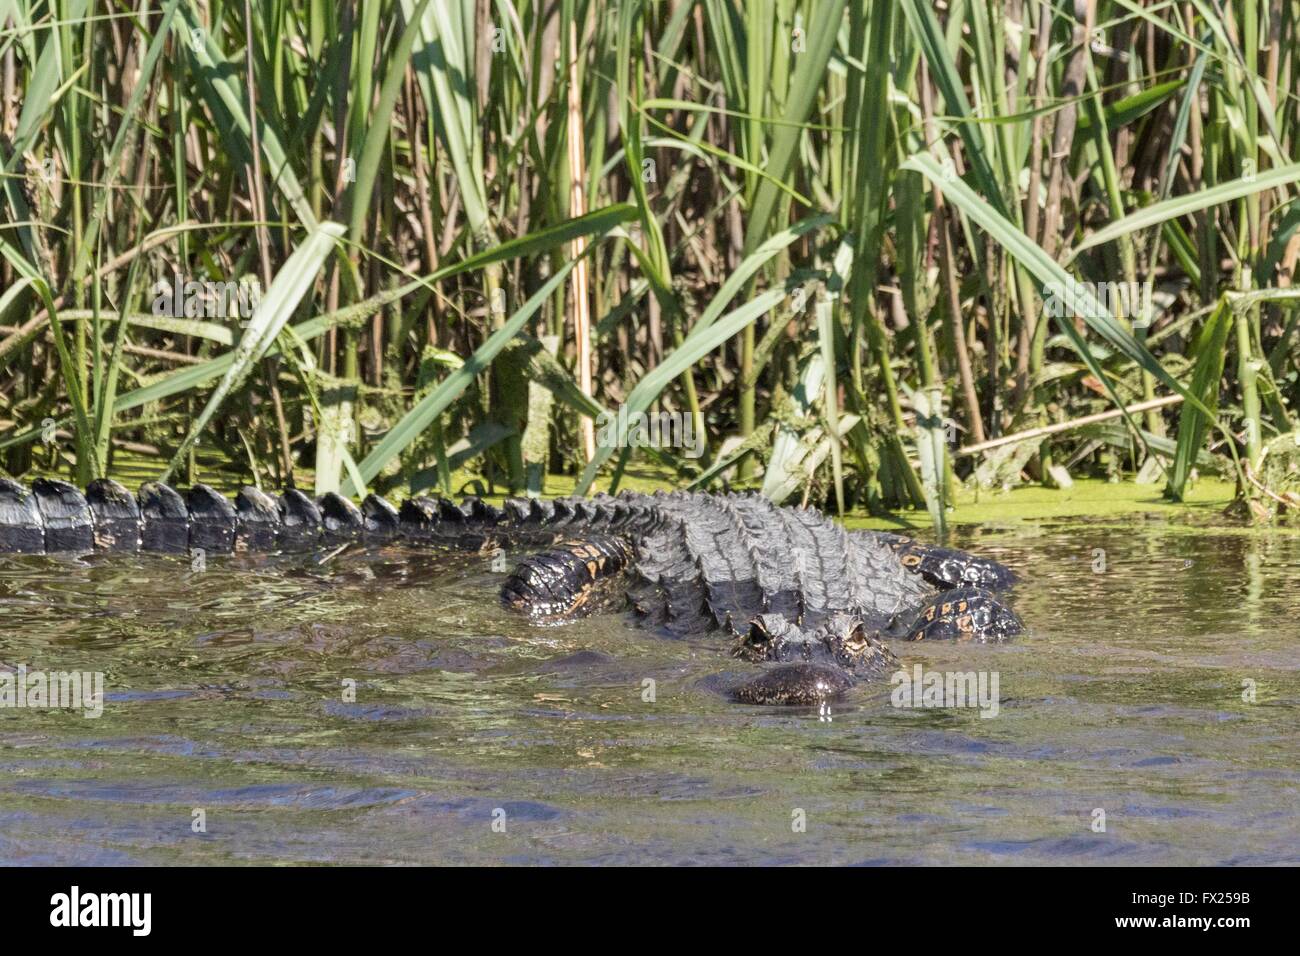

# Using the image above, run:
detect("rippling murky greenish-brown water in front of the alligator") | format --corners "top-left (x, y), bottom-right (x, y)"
top-left (0, 518), bottom-right (1300, 865)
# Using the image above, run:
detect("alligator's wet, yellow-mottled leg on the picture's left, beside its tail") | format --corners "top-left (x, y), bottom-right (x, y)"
top-left (501, 535), bottom-right (632, 623)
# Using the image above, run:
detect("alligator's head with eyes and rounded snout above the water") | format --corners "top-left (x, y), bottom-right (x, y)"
top-left (732, 614), bottom-right (898, 705)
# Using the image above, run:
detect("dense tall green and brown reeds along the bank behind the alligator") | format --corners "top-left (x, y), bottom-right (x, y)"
top-left (0, 0), bottom-right (1300, 522)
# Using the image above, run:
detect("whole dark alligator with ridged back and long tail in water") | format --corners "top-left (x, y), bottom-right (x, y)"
top-left (0, 479), bottom-right (1023, 705)
